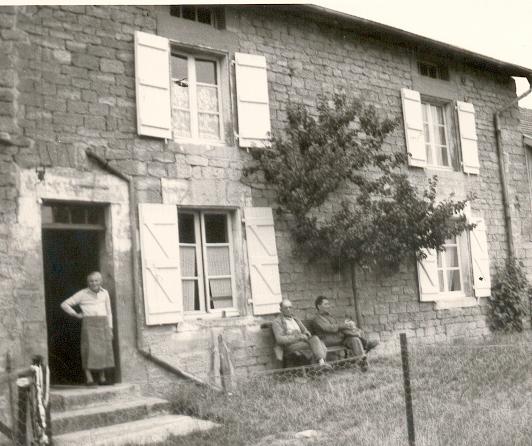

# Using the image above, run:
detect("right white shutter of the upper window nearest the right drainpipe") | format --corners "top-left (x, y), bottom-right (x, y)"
top-left (456, 101), bottom-right (480, 175)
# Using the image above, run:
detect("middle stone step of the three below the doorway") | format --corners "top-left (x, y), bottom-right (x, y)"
top-left (52, 396), bottom-right (170, 434)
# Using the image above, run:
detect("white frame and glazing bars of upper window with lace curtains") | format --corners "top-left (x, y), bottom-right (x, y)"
top-left (169, 51), bottom-right (225, 144)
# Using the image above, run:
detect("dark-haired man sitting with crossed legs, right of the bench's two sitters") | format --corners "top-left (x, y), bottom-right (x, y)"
top-left (312, 296), bottom-right (378, 357)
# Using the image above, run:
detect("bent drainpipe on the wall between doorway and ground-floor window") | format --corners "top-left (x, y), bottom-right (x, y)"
top-left (85, 149), bottom-right (222, 391)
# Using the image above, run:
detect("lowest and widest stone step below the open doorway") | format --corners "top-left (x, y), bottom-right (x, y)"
top-left (53, 415), bottom-right (219, 446)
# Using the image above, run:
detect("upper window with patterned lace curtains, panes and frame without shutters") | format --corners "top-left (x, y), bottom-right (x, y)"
top-left (171, 51), bottom-right (223, 141)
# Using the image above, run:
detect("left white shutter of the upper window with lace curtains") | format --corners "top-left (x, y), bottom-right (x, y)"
top-left (135, 31), bottom-right (172, 139)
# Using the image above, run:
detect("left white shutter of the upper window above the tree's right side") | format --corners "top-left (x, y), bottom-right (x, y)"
top-left (401, 88), bottom-right (427, 167)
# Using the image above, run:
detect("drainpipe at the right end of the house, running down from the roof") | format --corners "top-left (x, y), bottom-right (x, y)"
top-left (493, 77), bottom-right (532, 258)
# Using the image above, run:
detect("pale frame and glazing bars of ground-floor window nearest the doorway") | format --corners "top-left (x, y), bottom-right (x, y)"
top-left (177, 207), bottom-right (239, 318)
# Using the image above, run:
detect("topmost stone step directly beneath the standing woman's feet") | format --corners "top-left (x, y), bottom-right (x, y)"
top-left (50, 384), bottom-right (140, 412)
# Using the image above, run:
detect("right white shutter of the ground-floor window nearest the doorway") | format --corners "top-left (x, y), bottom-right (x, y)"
top-left (244, 208), bottom-right (281, 315)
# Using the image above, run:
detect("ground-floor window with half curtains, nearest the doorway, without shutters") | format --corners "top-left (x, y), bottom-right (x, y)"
top-left (178, 209), bottom-right (236, 313)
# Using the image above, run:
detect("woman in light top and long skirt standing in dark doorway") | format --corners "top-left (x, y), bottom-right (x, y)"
top-left (61, 271), bottom-right (115, 386)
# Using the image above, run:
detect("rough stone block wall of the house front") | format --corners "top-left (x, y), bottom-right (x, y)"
top-left (0, 6), bottom-right (532, 414)
